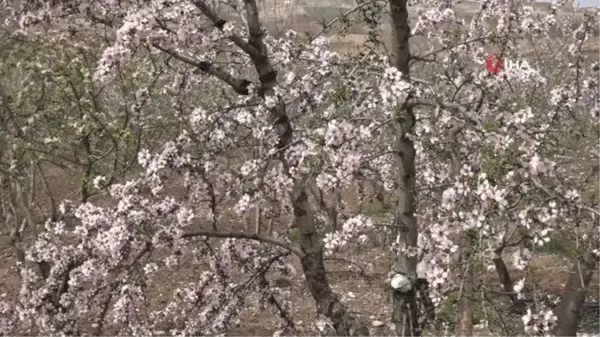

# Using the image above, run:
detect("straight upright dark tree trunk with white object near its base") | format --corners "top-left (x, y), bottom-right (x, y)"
top-left (389, 0), bottom-right (420, 337)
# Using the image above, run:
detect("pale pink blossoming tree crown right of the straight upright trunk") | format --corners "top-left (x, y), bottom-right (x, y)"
top-left (404, 2), bottom-right (598, 336)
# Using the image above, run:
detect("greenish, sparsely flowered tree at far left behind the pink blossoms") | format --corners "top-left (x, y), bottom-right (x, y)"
top-left (0, 14), bottom-right (176, 288)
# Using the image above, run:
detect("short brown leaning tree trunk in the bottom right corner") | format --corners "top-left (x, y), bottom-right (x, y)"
top-left (554, 245), bottom-right (596, 337)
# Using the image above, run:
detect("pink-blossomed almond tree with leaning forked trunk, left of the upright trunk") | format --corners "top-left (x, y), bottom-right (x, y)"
top-left (2, 1), bottom-right (380, 336)
